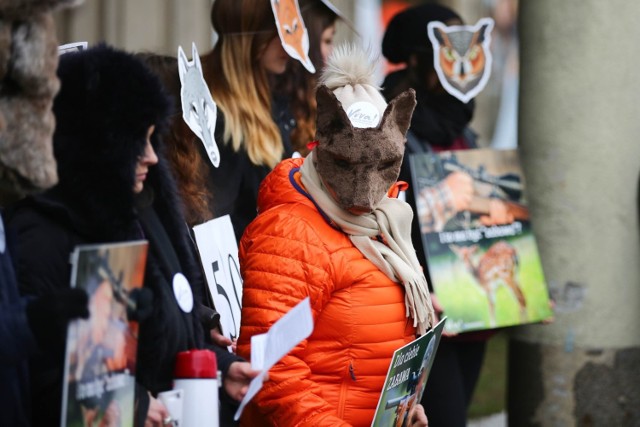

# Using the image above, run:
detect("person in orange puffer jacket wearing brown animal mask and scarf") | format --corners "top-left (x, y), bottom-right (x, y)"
top-left (238, 46), bottom-right (435, 426)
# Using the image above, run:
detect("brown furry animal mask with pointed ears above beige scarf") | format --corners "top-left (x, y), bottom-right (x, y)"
top-left (314, 85), bottom-right (416, 214)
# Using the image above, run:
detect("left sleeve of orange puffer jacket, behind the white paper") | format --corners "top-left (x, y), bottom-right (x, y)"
top-left (238, 208), bottom-right (348, 426)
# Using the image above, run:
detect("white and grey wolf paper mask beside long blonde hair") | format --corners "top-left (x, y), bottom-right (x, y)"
top-left (178, 43), bottom-right (220, 168)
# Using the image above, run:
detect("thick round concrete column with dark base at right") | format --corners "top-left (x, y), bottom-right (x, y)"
top-left (508, 0), bottom-right (640, 427)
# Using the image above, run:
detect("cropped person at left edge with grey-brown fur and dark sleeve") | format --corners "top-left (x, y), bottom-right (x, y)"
top-left (0, 0), bottom-right (89, 427)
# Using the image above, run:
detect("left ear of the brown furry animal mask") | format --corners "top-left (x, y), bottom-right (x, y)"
top-left (316, 85), bottom-right (353, 144)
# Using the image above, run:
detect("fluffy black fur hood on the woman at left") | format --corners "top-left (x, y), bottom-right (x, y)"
top-left (53, 44), bottom-right (173, 237)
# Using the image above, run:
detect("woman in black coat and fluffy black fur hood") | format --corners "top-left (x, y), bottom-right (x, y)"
top-left (9, 45), bottom-right (252, 425)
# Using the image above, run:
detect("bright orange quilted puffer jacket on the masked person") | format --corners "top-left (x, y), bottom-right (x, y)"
top-left (238, 159), bottom-right (415, 427)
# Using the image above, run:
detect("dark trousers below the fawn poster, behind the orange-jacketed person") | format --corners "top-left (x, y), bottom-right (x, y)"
top-left (421, 337), bottom-right (486, 427)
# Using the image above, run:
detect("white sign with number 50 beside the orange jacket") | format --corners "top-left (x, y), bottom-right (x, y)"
top-left (193, 215), bottom-right (242, 339)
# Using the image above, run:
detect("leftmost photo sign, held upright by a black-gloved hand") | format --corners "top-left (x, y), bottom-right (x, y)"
top-left (60, 240), bottom-right (148, 427)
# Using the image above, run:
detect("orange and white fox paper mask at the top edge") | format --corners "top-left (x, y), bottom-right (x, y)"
top-left (271, 0), bottom-right (316, 73)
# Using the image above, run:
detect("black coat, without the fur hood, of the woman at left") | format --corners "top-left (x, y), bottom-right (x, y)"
top-left (10, 173), bottom-right (241, 425)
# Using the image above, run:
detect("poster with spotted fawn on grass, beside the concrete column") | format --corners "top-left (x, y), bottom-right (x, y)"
top-left (409, 149), bottom-right (552, 332)
